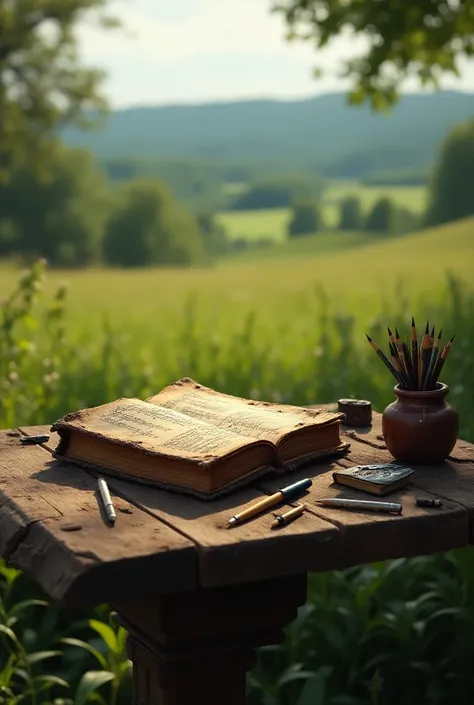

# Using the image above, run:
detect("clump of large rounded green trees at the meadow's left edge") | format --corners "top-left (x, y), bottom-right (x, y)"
top-left (0, 146), bottom-right (230, 267)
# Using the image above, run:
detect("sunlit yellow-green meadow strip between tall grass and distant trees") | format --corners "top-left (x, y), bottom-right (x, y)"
top-left (0, 219), bottom-right (474, 331)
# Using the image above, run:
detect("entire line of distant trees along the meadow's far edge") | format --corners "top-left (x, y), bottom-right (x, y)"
top-left (0, 115), bottom-right (474, 267)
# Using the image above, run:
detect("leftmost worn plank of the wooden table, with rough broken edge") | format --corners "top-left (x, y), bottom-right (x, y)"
top-left (0, 431), bottom-right (197, 604)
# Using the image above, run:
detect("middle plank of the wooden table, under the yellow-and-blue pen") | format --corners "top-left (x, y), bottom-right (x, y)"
top-left (22, 426), bottom-right (343, 587)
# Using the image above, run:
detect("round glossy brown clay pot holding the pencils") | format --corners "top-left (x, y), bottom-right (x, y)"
top-left (382, 383), bottom-right (459, 465)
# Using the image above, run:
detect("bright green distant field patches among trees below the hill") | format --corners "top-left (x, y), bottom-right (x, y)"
top-left (218, 181), bottom-right (426, 242)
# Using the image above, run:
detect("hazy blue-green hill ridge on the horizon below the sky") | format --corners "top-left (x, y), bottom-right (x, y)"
top-left (63, 91), bottom-right (474, 174)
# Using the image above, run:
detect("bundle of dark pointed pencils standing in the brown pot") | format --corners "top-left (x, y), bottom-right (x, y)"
top-left (366, 318), bottom-right (454, 391)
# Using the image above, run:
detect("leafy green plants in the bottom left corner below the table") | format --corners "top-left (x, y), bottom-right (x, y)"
top-left (0, 560), bottom-right (131, 705)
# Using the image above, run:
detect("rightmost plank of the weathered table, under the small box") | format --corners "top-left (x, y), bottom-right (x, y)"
top-left (260, 412), bottom-right (474, 571)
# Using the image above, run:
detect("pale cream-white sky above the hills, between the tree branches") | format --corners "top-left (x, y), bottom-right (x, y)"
top-left (79, 0), bottom-right (474, 108)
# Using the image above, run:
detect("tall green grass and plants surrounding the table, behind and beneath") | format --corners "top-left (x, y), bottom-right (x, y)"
top-left (0, 262), bottom-right (474, 705)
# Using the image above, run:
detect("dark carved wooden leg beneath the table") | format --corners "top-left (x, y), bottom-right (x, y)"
top-left (113, 575), bottom-right (306, 705)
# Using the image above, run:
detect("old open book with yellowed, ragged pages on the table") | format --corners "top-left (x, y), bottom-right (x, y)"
top-left (51, 377), bottom-right (349, 498)
